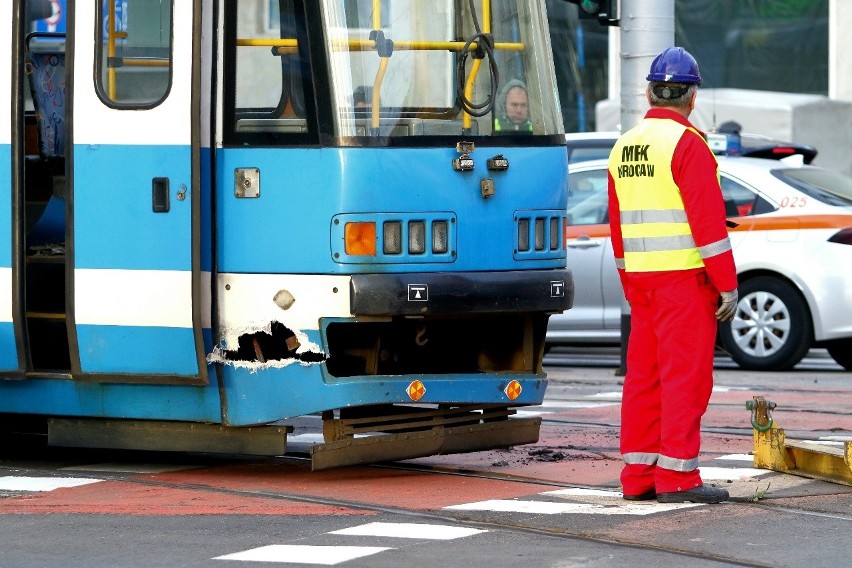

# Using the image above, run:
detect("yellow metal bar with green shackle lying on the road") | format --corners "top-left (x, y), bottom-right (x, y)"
top-left (746, 396), bottom-right (852, 485)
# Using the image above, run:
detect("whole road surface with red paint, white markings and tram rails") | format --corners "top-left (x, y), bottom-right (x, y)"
top-left (0, 353), bottom-right (852, 568)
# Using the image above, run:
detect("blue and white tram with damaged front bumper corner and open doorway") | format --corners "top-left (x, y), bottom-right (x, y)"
top-left (0, 0), bottom-right (573, 469)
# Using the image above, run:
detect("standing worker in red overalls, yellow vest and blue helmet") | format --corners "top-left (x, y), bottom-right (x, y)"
top-left (609, 47), bottom-right (738, 503)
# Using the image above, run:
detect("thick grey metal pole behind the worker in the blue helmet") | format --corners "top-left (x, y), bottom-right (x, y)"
top-left (616, 0), bottom-right (674, 376)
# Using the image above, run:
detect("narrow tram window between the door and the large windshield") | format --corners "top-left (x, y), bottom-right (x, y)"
top-left (233, 0), bottom-right (308, 135)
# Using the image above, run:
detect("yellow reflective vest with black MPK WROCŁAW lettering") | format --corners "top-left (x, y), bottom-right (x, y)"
top-left (609, 118), bottom-right (704, 272)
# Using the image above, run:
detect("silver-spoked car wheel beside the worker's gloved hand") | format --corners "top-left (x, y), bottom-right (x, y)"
top-left (719, 276), bottom-right (813, 371)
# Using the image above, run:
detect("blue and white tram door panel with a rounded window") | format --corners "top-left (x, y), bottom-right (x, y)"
top-left (69, 0), bottom-right (206, 382)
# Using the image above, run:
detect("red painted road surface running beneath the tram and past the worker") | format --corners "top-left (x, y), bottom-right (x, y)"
top-left (0, 369), bottom-right (852, 515)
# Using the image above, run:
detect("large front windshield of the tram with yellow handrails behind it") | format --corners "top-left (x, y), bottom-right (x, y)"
top-left (322, 0), bottom-right (562, 136)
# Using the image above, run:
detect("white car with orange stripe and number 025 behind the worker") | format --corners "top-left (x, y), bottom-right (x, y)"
top-left (547, 156), bottom-right (852, 371)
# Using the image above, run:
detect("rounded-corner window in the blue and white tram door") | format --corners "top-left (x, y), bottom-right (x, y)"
top-left (95, 0), bottom-right (172, 108)
